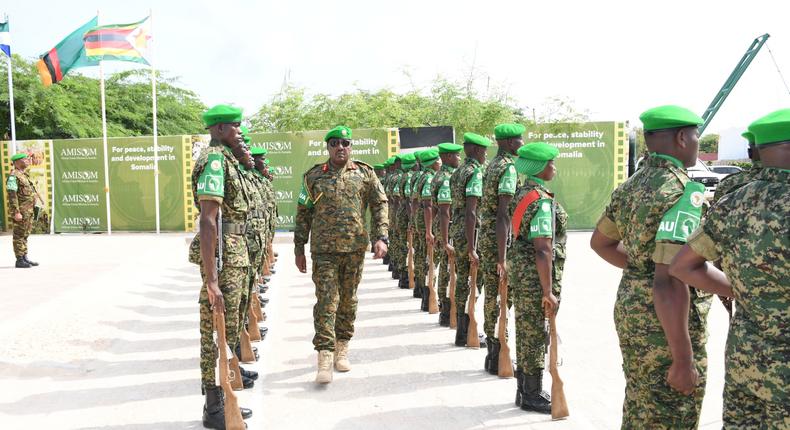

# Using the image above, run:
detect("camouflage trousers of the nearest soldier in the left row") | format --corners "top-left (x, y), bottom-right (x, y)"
top-left (198, 266), bottom-right (248, 389)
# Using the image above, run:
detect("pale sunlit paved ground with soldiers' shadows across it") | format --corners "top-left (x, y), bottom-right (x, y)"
top-left (0, 233), bottom-right (727, 430)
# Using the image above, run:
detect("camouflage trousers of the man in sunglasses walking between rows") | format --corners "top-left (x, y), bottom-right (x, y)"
top-left (312, 250), bottom-right (365, 351)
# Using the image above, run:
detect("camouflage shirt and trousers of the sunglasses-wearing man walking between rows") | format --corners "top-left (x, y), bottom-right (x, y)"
top-left (294, 161), bottom-right (387, 351)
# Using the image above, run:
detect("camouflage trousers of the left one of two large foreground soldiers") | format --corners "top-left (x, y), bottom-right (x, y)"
top-left (614, 269), bottom-right (710, 429)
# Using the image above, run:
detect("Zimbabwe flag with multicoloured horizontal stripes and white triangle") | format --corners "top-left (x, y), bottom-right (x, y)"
top-left (83, 17), bottom-right (151, 64)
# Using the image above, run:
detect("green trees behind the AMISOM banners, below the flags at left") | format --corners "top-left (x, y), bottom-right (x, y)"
top-left (0, 55), bottom-right (206, 140)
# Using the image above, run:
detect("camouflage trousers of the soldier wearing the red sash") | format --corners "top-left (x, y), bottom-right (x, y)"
top-left (508, 260), bottom-right (564, 375)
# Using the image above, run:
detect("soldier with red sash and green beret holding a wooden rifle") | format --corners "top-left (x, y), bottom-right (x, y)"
top-left (507, 142), bottom-right (568, 414)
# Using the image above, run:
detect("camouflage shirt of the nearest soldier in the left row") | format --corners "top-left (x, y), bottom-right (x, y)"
top-left (189, 140), bottom-right (251, 267)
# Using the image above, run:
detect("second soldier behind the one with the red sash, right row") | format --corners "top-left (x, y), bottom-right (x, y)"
top-left (450, 133), bottom-right (491, 347)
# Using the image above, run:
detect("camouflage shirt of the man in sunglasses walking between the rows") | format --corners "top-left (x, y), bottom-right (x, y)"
top-left (294, 160), bottom-right (388, 255)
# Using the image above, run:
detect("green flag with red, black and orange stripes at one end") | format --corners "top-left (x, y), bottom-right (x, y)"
top-left (36, 17), bottom-right (99, 87)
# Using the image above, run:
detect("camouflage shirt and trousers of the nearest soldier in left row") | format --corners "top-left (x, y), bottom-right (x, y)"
top-left (189, 140), bottom-right (250, 389)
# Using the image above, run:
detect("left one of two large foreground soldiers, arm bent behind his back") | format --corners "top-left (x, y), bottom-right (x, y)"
top-left (590, 106), bottom-right (711, 429)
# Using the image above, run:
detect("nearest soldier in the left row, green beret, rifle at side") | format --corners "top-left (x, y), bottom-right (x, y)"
top-left (189, 105), bottom-right (251, 428)
